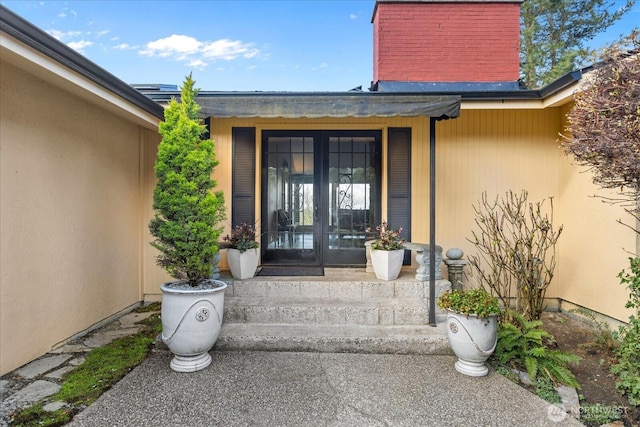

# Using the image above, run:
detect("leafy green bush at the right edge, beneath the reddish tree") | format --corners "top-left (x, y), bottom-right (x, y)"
top-left (611, 257), bottom-right (640, 406)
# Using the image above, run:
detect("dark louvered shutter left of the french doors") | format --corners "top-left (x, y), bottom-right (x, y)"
top-left (231, 128), bottom-right (256, 227)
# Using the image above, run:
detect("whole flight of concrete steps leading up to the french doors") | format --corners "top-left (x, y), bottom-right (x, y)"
top-left (216, 276), bottom-right (451, 354)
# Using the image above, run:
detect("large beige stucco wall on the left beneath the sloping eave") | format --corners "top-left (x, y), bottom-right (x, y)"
top-left (0, 61), bottom-right (159, 374)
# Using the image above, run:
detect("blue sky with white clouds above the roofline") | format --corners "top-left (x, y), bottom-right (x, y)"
top-left (0, 0), bottom-right (640, 91)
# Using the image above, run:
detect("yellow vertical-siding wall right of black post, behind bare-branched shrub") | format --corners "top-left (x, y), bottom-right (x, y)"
top-left (436, 109), bottom-right (562, 296)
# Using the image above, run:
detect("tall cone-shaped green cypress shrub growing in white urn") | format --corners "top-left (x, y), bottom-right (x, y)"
top-left (149, 75), bottom-right (225, 286)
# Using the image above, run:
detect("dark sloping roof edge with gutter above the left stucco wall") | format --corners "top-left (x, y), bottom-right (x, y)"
top-left (0, 5), bottom-right (164, 119)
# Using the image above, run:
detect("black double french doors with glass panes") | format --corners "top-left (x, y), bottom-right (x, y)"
top-left (261, 131), bottom-right (381, 265)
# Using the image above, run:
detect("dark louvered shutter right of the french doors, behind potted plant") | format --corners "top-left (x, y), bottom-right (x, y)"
top-left (387, 128), bottom-right (411, 265)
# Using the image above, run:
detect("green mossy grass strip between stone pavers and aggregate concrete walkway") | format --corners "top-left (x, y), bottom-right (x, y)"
top-left (11, 303), bottom-right (162, 427)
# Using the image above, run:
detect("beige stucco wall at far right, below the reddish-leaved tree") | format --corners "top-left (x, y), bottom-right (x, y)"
top-left (558, 105), bottom-right (640, 321)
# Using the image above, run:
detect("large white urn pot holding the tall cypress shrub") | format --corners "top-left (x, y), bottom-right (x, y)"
top-left (160, 279), bottom-right (227, 372)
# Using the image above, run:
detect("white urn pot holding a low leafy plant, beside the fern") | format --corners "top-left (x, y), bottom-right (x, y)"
top-left (447, 310), bottom-right (498, 377)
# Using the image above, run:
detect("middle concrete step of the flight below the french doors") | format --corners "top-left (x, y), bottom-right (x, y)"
top-left (224, 296), bottom-right (443, 325)
